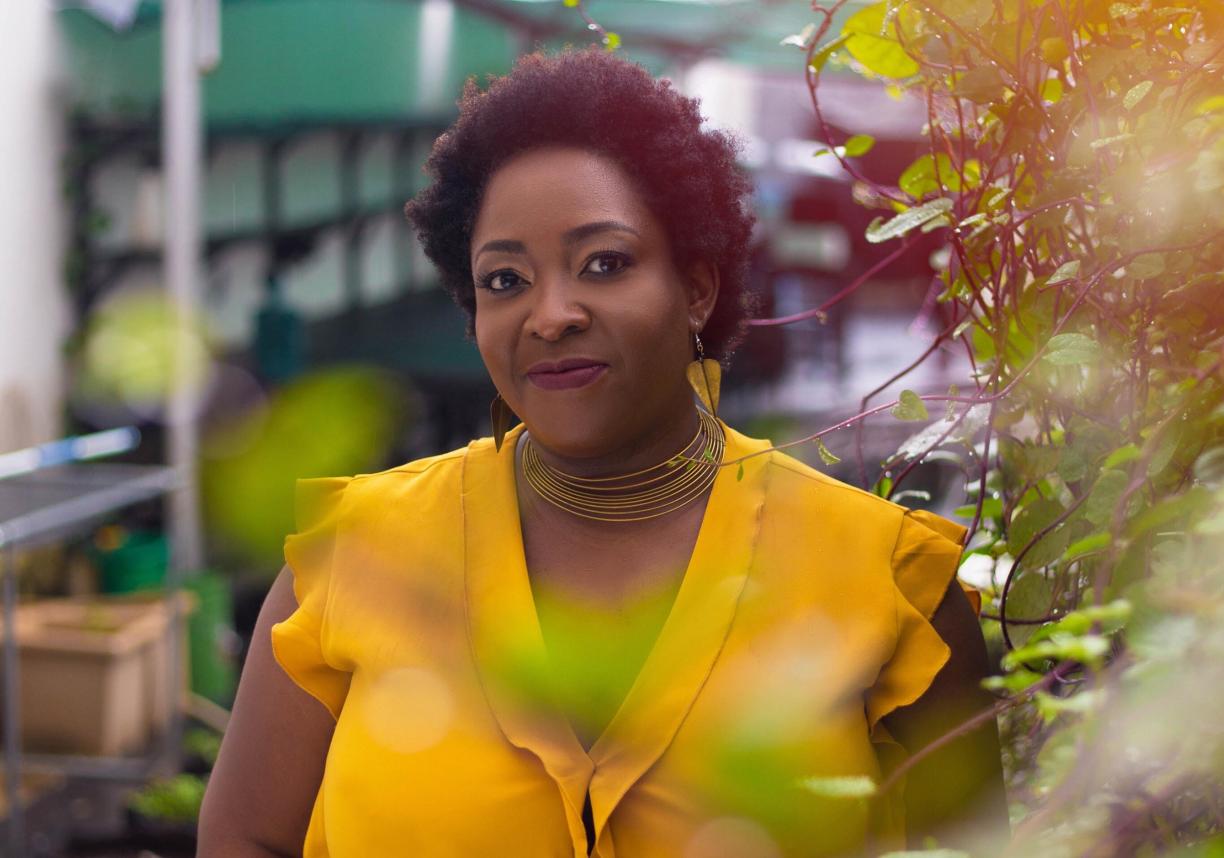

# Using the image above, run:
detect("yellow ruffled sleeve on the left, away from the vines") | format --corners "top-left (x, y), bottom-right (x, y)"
top-left (272, 477), bottom-right (351, 718)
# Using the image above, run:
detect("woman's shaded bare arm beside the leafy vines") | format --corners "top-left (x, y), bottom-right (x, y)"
top-left (884, 579), bottom-right (1009, 854)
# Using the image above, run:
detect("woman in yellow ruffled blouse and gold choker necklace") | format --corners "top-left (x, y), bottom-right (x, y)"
top-left (200, 51), bottom-right (1001, 858)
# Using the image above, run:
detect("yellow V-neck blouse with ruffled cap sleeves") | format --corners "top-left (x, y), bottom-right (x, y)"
top-left (272, 427), bottom-right (963, 858)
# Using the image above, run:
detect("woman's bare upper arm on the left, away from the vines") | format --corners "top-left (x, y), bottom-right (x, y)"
top-left (196, 567), bottom-right (335, 858)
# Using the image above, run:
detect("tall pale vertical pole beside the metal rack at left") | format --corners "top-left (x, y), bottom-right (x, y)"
top-left (162, 0), bottom-right (203, 569)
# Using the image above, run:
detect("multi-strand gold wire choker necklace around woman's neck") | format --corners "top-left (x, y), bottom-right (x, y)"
top-left (523, 409), bottom-right (726, 521)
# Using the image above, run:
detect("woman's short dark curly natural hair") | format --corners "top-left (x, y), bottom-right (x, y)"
top-left (404, 48), bottom-right (754, 360)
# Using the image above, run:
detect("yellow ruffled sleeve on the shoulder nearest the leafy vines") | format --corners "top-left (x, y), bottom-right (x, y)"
top-left (867, 509), bottom-right (979, 740)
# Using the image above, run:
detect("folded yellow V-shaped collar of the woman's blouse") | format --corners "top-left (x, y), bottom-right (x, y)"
top-left (463, 425), bottom-right (769, 854)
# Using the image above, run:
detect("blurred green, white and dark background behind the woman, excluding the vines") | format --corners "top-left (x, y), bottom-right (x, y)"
top-left (0, 0), bottom-right (968, 856)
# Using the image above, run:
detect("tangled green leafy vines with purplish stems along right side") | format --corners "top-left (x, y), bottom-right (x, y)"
top-left (783, 0), bottom-right (1224, 856)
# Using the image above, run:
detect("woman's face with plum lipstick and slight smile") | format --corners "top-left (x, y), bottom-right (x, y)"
top-left (471, 148), bottom-right (717, 459)
